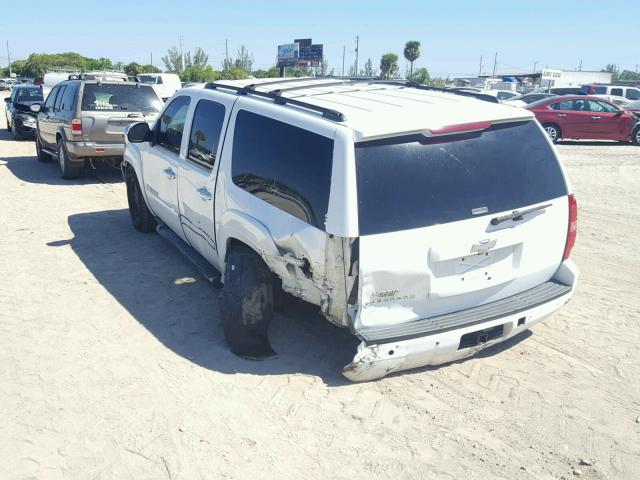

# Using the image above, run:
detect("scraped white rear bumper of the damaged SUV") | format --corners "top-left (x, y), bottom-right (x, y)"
top-left (342, 261), bottom-right (578, 382)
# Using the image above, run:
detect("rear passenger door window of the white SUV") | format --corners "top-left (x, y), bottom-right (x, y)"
top-left (187, 100), bottom-right (225, 168)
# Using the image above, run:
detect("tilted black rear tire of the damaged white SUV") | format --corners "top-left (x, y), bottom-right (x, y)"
top-left (220, 246), bottom-right (275, 360)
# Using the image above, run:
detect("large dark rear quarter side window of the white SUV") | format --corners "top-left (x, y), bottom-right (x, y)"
top-left (231, 110), bottom-right (333, 230)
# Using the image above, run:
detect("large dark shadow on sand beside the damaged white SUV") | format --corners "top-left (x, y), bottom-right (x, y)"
top-left (57, 209), bottom-right (358, 386)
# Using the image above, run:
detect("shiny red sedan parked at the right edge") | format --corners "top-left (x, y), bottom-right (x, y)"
top-left (525, 95), bottom-right (640, 145)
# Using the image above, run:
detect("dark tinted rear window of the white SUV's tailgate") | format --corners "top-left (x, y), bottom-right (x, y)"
top-left (355, 122), bottom-right (567, 235)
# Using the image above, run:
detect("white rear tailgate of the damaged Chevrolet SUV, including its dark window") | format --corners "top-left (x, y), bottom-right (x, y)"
top-left (355, 121), bottom-right (568, 330)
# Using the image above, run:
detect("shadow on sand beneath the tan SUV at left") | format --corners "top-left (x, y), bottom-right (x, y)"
top-left (0, 155), bottom-right (123, 185)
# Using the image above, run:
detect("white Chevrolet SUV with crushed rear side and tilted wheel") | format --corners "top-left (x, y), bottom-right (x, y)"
top-left (122, 78), bottom-right (578, 381)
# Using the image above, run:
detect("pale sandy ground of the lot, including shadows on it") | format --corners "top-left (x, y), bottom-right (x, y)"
top-left (0, 94), bottom-right (640, 480)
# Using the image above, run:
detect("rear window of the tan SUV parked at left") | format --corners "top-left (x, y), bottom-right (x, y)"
top-left (82, 83), bottom-right (162, 113)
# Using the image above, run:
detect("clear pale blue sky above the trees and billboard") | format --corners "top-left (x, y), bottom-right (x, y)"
top-left (0, 0), bottom-right (640, 76)
